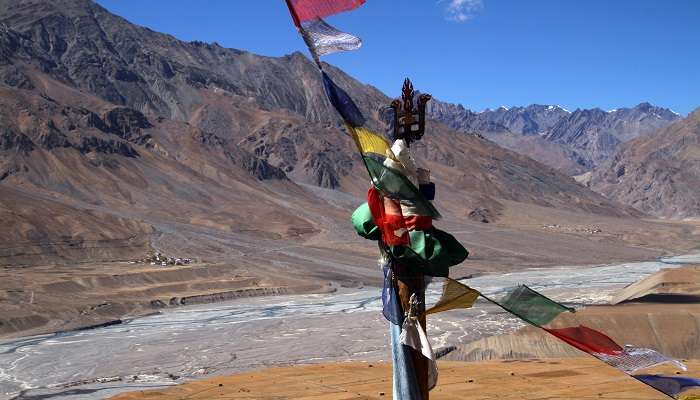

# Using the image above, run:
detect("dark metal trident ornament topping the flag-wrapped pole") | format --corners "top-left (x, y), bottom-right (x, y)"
top-left (391, 78), bottom-right (432, 145)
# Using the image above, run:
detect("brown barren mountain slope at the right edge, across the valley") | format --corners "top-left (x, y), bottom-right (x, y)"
top-left (590, 110), bottom-right (700, 218)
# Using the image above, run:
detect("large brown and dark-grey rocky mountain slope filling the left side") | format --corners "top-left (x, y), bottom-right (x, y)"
top-left (0, 0), bottom-right (640, 262)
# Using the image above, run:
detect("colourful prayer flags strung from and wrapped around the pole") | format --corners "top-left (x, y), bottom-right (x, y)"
top-left (286, 0), bottom-right (700, 400)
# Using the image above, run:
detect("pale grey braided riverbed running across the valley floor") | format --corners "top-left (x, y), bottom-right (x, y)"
top-left (0, 254), bottom-right (700, 399)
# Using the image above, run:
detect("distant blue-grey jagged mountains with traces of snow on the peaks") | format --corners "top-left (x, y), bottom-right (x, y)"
top-left (429, 101), bottom-right (681, 175)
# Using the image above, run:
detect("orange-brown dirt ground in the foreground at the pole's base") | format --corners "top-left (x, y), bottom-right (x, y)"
top-left (112, 357), bottom-right (700, 400)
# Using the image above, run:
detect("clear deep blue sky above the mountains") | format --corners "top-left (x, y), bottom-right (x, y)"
top-left (98, 0), bottom-right (700, 114)
